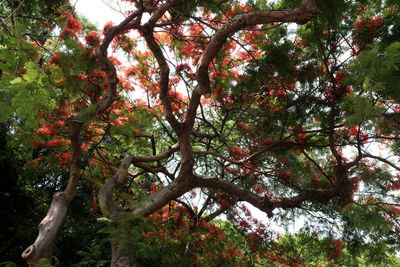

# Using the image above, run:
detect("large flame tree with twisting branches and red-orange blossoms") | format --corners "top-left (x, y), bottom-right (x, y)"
top-left (0, 0), bottom-right (400, 266)
